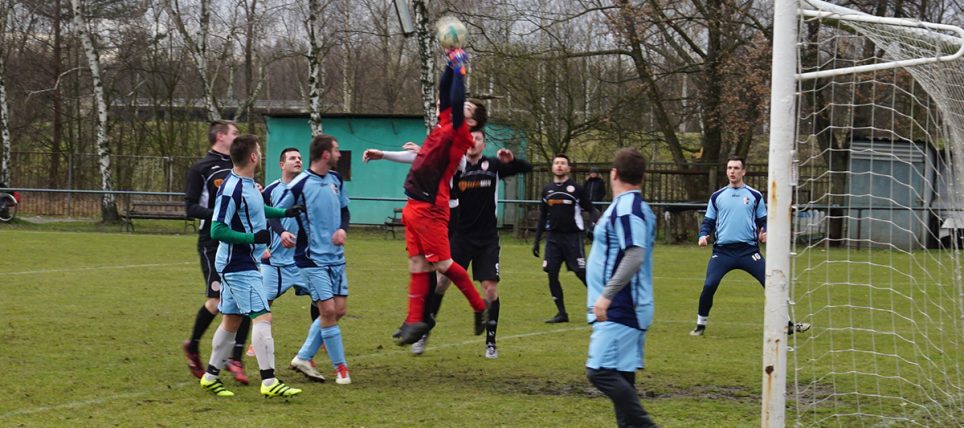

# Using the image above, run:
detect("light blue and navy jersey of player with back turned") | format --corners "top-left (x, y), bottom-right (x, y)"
top-left (586, 190), bottom-right (656, 330)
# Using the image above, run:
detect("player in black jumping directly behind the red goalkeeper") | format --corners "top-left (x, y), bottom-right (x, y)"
top-left (412, 131), bottom-right (532, 358)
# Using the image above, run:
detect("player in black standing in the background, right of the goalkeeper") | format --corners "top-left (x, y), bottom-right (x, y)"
top-left (532, 154), bottom-right (596, 324)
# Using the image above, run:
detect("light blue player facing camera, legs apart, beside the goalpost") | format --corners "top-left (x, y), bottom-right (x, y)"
top-left (690, 156), bottom-right (810, 336)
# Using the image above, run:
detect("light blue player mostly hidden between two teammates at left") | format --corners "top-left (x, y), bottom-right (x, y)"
top-left (261, 147), bottom-right (325, 382)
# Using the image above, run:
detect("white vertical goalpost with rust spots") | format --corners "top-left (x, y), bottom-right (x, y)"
top-left (760, 0), bottom-right (797, 428)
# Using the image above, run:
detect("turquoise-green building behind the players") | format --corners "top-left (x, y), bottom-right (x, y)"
top-left (265, 114), bottom-right (526, 224)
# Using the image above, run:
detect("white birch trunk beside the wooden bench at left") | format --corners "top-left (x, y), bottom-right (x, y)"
top-left (70, 0), bottom-right (120, 223)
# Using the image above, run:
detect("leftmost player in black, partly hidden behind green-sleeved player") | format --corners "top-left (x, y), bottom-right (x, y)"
top-left (184, 121), bottom-right (251, 385)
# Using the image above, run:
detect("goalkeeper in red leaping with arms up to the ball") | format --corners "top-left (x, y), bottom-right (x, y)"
top-left (395, 49), bottom-right (488, 345)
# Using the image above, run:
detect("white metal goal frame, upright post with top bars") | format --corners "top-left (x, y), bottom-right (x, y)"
top-left (761, 0), bottom-right (964, 427)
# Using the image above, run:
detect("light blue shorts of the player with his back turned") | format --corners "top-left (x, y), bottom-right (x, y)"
top-left (586, 321), bottom-right (646, 372)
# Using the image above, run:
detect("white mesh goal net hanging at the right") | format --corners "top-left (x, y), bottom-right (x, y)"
top-left (784, 0), bottom-right (964, 426)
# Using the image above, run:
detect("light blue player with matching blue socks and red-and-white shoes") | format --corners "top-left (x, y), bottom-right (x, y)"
top-left (278, 134), bottom-right (351, 385)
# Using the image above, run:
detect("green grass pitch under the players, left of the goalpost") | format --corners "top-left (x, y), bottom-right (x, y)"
top-left (0, 224), bottom-right (952, 427)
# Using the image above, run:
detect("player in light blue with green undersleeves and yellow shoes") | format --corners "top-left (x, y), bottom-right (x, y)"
top-left (200, 134), bottom-right (301, 397)
